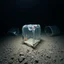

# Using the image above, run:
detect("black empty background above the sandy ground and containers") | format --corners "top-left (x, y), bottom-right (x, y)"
top-left (0, 0), bottom-right (64, 35)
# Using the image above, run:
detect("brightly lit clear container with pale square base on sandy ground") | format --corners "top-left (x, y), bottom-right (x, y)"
top-left (22, 24), bottom-right (41, 46)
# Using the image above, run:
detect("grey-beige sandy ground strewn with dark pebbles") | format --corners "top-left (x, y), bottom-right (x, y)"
top-left (0, 35), bottom-right (64, 64)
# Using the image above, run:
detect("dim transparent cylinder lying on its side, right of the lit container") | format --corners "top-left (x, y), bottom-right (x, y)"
top-left (45, 26), bottom-right (60, 36)
